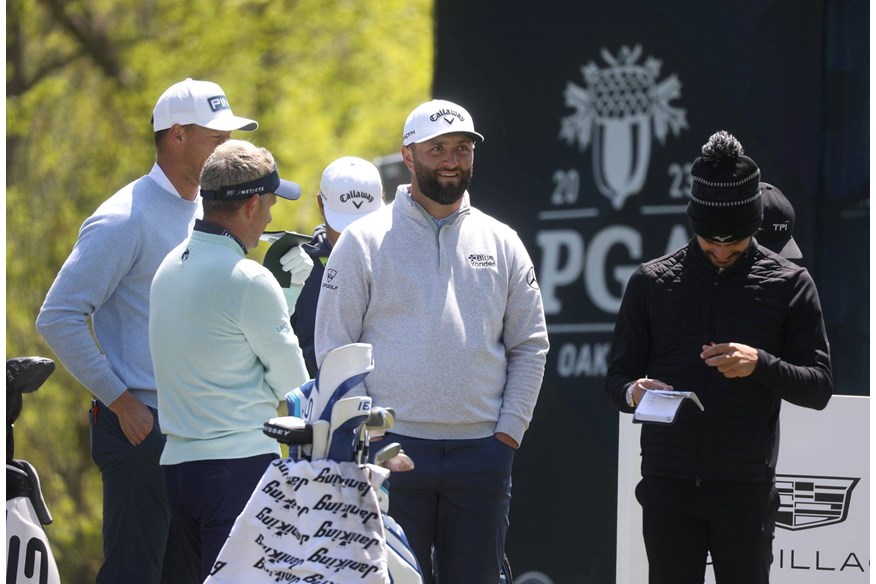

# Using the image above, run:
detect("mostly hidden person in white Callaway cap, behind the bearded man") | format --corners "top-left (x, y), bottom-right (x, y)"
top-left (288, 156), bottom-right (383, 377)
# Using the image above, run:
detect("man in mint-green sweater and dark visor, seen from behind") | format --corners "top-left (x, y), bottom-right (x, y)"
top-left (149, 140), bottom-right (312, 582)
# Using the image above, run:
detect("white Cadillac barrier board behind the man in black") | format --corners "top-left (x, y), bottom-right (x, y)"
top-left (617, 395), bottom-right (870, 584)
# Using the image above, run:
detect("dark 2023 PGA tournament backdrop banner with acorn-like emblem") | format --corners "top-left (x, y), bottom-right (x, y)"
top-left (433, 0), bottom-right (822, 584)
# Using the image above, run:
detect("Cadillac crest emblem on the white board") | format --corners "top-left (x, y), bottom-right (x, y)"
top-left (776, 475), bottom-right (861, 531)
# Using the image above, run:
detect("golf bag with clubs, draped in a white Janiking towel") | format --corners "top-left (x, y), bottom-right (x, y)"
top-left (205, 343), bottom-right (422, 584)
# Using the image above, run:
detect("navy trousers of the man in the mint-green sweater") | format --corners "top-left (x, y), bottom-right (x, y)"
top-left (163, 454), bottom-right (279, 582)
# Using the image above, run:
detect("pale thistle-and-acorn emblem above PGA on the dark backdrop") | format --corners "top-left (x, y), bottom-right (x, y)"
top-left (560, 45), bottom-right (688, 210)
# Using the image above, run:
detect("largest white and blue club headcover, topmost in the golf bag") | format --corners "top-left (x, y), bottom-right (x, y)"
top-left (307, 343), bottom-right (374, 422)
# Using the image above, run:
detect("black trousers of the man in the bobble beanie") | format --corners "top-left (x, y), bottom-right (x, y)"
top-left (636, 477), bottom-right (779, 584)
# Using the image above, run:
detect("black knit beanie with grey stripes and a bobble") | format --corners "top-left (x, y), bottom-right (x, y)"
top-left (687, 131), bottom-right (763, 243)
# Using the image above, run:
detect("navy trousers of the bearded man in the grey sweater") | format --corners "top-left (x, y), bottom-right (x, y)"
top-left (384, 433), bottom-right (514, 584)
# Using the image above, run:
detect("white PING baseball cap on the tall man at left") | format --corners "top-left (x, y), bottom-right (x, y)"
top-left (152, 77), bottom-right (259, 132)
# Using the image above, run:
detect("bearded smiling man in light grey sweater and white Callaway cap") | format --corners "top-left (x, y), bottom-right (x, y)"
top-left (316, 100), bottom-right (548, 584)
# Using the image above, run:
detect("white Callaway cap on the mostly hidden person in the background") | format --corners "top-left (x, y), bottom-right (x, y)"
top-left (319, 156), bottom-right (383, 233)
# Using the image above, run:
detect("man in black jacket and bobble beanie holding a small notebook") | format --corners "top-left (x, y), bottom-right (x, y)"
top-left (606, 132), bottom-right (833, 584)
